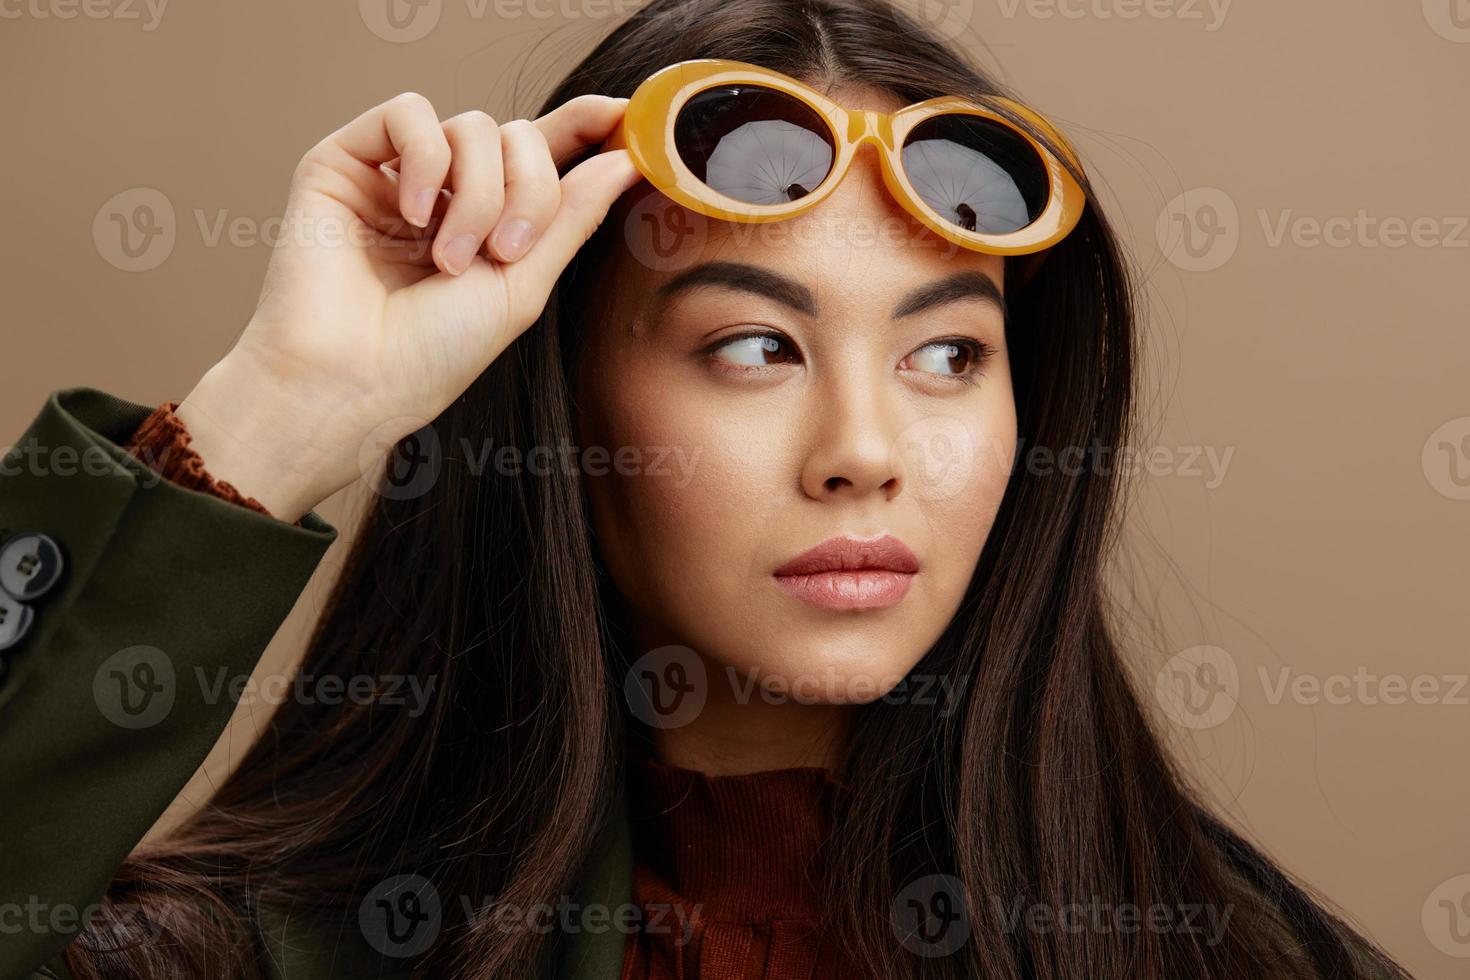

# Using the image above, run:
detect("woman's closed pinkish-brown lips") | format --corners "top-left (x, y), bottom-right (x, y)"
top-left (772, 535), bottom-right (919, 610)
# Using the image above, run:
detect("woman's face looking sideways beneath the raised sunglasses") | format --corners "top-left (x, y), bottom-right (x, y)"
top-left (576, 93), bottom-right (1016, 752)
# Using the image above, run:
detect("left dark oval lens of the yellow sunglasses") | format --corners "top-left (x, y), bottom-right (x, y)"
top-left (673, 85), bottom-right (835, 204)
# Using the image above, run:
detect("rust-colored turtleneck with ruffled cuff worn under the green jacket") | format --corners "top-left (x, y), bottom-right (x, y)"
top-left (123, 401), bottom-right (863, 980)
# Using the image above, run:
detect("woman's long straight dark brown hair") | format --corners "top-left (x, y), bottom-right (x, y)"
top-left (68, 0), bottom-right (1405, 980)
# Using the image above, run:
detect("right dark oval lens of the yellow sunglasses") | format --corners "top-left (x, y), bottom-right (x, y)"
top-left (903, 113), bottom-right (1051, 235)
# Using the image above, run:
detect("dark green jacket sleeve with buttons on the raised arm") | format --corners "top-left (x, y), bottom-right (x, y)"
top-left (0, 388), bottom-right (337, 979)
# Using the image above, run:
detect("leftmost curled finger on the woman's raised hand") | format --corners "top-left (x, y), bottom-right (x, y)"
top-left (328, 93), bottom-right (450, 228)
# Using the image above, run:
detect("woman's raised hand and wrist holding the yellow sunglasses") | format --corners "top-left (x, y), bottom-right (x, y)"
top-left (178, 94), bottom-right (639, 522)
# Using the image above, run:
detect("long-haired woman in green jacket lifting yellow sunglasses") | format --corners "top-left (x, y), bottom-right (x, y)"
top-left (0, 0), bottom-right (1404, 980)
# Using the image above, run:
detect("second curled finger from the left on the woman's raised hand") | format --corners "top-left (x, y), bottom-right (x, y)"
top-left (434, 110), bottom-right (506, 276)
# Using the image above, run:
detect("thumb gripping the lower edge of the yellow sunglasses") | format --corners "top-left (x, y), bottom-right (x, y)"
top-left (504, 150), bottom-right (642, 315)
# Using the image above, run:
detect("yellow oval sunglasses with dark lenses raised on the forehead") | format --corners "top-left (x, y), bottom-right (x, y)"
top-left (604, 59), bottom-right (1086, 267)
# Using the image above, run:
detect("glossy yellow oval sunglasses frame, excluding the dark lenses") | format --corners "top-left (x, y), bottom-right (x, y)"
top-left (604, 59), bottom-right (1086, 260)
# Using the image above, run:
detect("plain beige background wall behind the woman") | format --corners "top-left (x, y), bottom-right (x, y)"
top-left (0, 0), bottom-right (1470, 980)
